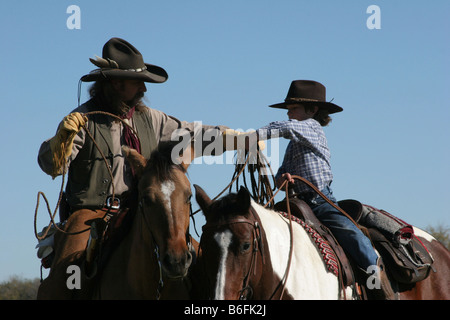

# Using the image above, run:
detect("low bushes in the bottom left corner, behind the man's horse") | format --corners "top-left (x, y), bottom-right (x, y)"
top-left (0, 276), bottom-right (40, 300)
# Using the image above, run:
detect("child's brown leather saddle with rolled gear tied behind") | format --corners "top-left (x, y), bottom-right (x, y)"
top-left (275, 198), bottom-right (435, 286)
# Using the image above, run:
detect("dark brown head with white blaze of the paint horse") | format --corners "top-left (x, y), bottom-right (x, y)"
top-left (194, 185), bottom-right (264, 300)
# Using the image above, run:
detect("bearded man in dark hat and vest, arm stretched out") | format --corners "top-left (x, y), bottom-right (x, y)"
top-left (38, 38), bottom-right (232, 298)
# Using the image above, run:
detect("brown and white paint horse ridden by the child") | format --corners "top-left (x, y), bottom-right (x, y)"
top-left (195, 186), bottom-right (450, 300)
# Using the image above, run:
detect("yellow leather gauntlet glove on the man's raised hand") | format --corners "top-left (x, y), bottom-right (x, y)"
top-left (50, 112), bottom-right (87, 178)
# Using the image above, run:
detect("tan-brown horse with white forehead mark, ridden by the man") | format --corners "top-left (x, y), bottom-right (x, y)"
top-left (38, 143), bottom-right (198, 299)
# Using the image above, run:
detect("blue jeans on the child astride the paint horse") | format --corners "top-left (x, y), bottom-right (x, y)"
top-left (307, 186), bottom-right (378, 270)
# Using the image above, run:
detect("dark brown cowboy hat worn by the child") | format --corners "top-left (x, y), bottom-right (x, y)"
top-left (269, 80), bottom-right (344, 114)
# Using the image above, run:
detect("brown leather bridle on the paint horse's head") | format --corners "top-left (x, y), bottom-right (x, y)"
top-left (200, 207), bottom-right (265, 300)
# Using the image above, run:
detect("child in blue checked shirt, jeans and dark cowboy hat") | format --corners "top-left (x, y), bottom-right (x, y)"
top-left (257, 80), bottom-right (394, 299)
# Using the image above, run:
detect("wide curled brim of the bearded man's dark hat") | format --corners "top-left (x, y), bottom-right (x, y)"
top-left (81, 63), bottom-right (169, 83)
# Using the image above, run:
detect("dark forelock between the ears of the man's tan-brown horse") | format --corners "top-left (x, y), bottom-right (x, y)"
top-left (145, 141), bottom-right (186, 182)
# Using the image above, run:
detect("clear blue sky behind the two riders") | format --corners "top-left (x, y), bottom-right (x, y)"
top-left (0, 0), bottom-right (450, 281)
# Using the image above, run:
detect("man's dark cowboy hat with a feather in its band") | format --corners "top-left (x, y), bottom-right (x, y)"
top-left (81, 38), bottom-right (168, 83)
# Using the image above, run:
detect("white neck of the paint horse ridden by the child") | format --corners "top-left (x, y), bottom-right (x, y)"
top-left (252, 202), bottom-right (338, 299)
